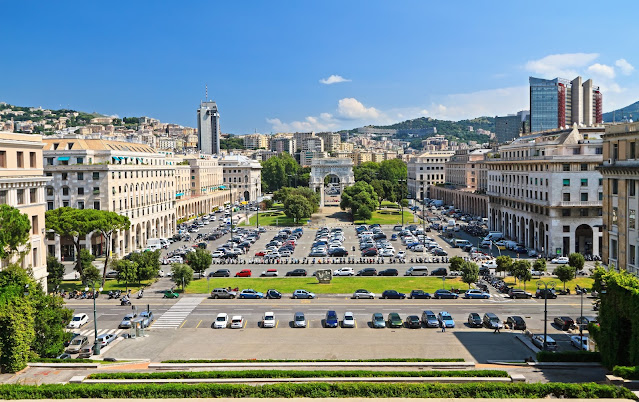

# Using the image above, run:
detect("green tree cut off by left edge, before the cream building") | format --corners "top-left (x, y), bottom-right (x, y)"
top-left (0, 204), bottom-right (31, 260)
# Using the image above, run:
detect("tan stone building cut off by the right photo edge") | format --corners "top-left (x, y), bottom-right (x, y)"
top-left (600, 123), bottom-right (639, 276)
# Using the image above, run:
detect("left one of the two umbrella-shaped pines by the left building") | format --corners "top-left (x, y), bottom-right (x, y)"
top-left (45, 207), bottom-right (95, 275)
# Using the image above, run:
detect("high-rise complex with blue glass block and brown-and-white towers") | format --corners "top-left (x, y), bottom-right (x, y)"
top-left (529, 77), bottom-right (603, 132)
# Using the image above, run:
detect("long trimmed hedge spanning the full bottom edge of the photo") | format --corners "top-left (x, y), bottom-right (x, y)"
top-left (0, 382), bottom-right (637, 400)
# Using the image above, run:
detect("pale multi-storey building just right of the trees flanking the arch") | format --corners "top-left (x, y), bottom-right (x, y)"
top-left (407, 151), bottom-right (454, 200)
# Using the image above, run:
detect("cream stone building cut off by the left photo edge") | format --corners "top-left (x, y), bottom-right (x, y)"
top-left (0, 132), bottom-right (49, 291)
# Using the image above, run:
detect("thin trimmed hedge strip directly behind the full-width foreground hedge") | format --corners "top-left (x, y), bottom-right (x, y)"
top-left (87, 370), bottom-right (508, 380)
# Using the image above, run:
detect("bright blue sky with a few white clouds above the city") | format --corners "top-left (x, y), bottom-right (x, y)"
top-left (0, 0), bottom-right (639, 134)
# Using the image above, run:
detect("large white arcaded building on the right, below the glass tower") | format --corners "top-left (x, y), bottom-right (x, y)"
top-left (486, 125), bottom-right (604, 256)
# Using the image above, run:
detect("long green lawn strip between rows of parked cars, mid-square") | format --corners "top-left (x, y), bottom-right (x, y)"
top-left (186, 276), bottom-right (468, 294)
